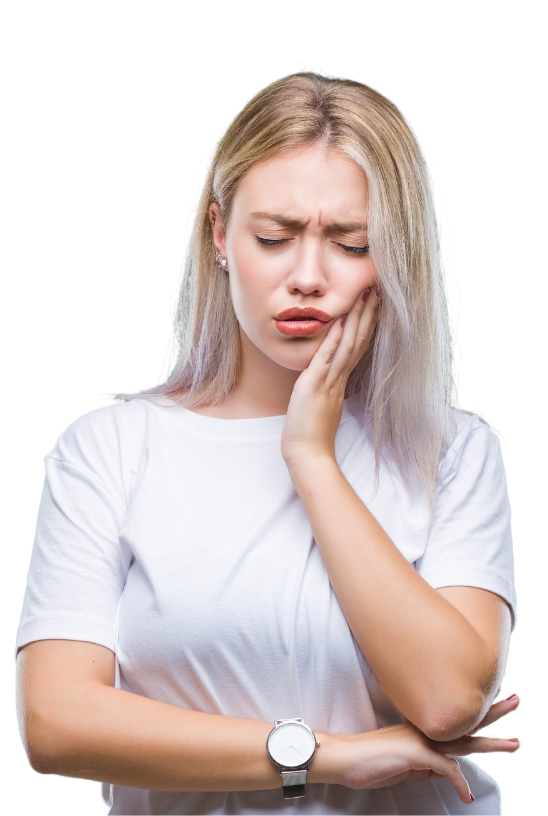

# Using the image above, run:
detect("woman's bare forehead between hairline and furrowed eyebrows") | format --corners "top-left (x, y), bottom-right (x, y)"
top-left (234, 146), bottom-right (368, 221)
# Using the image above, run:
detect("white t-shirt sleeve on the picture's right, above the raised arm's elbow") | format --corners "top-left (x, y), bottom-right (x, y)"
top-left (415, 415), bottom-right (517, 634)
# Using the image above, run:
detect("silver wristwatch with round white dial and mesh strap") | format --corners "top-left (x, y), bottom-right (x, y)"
top-left (266, 717), bottom-right (320, 799)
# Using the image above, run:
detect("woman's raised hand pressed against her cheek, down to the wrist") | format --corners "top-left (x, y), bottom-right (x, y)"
top-left (281, 287), bottom-right (380, 467)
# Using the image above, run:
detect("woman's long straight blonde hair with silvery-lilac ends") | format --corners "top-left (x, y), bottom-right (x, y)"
top-left (99, 69), bottom-right (511, 514)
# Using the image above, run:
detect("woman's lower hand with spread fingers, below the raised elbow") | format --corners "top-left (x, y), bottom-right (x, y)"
top-left (332, 697), bottom-right (521, 805)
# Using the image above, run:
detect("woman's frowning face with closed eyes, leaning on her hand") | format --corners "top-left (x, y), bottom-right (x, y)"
top-left (210, 146), bottom-right (376, 414)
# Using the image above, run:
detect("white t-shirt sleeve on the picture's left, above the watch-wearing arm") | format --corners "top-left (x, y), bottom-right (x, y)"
top-left (14, 408), bottom-right (131, 659)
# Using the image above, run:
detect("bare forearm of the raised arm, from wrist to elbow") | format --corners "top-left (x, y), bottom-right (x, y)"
top-left (291, 459), bottom-right (485, 739)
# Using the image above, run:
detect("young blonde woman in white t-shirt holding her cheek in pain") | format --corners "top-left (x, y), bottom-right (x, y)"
top-left (15, 70), bottom-right (520, 816)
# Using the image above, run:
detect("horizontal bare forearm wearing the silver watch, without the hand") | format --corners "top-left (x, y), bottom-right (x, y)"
top-left (34, 684), bottom-right (338, 797)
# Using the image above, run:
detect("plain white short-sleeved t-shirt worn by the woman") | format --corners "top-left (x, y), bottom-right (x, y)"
top-left (14, 399), bottom-right (517, 816)
